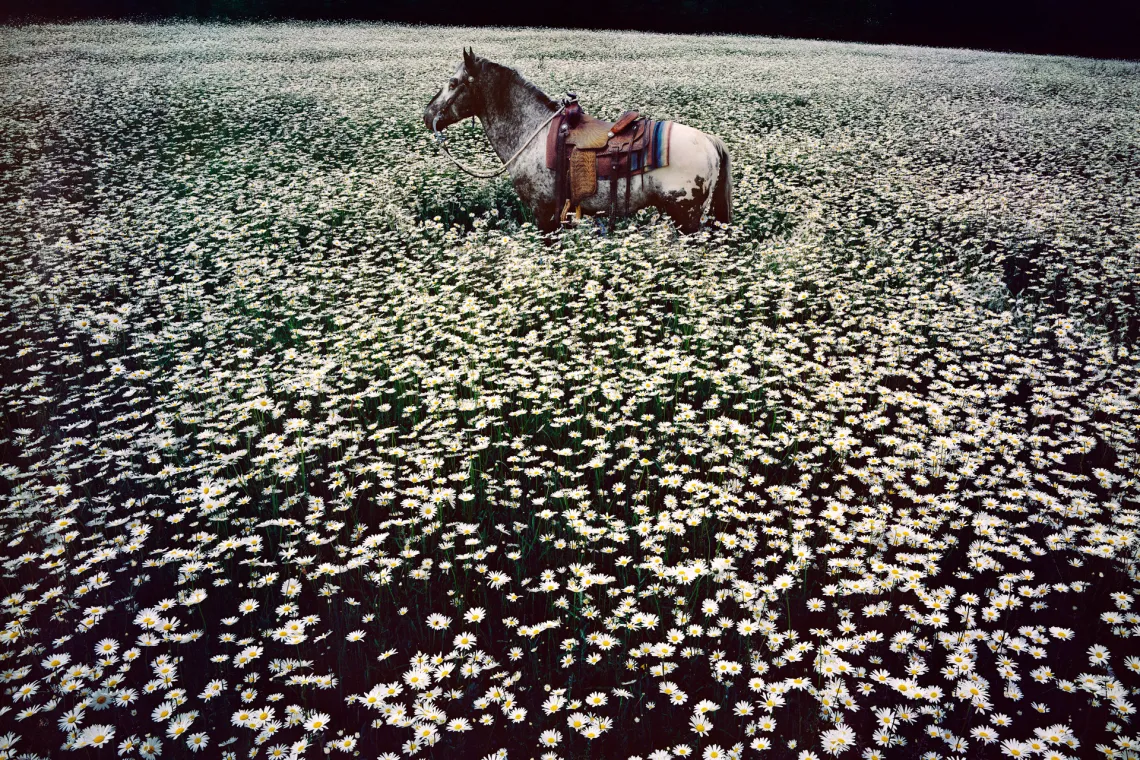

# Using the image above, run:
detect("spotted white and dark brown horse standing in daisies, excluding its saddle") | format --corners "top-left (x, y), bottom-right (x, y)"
top-left (423, 49), bottom-right (732, 234)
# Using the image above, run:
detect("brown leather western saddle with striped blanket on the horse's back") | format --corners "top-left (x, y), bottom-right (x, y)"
top-left (546, 101), bottom-right (673, 230)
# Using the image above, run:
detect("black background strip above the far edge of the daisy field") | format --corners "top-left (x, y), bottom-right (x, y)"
top-left (0, 0), bottom-right (1140, 59)
